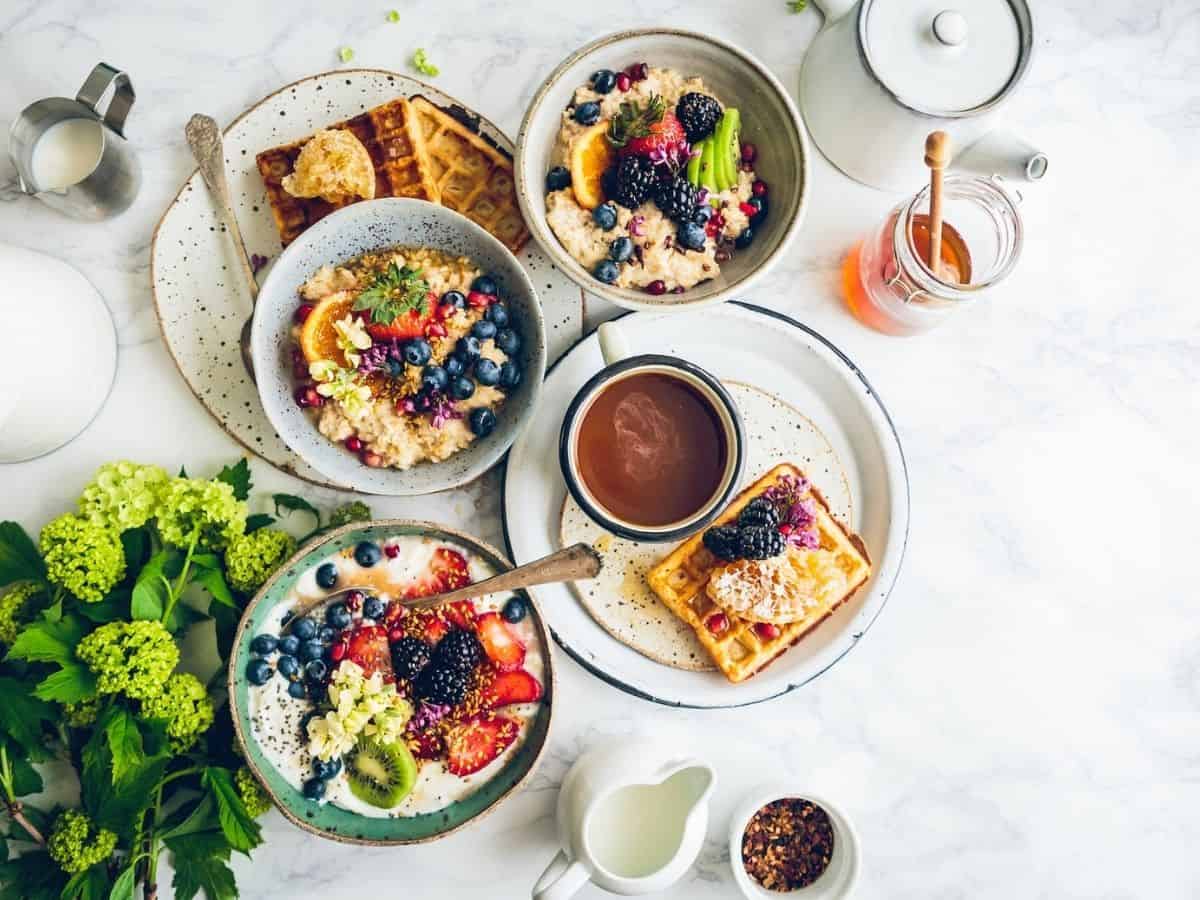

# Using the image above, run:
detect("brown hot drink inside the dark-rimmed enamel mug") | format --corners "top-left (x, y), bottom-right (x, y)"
top-left (575, 372), bottom-right (730, 527)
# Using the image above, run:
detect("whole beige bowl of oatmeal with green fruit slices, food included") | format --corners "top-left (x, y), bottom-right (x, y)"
top-left (515, 29), bottom-right (809, 311)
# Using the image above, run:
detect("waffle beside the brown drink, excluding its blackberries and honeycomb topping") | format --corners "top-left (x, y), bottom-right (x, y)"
top-left (647, 463), bottom-right (871, 683)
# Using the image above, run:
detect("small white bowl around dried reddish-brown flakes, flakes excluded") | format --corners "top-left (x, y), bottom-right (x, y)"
top-left (730, 784), bottom-right (862, 900)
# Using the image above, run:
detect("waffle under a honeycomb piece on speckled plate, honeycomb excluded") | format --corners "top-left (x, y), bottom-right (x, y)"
top-left (256, 97), bottom-right (438, 246)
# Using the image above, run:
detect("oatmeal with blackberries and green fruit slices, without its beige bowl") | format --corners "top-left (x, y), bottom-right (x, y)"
top-left (546, 62), bottom-right (767, 294)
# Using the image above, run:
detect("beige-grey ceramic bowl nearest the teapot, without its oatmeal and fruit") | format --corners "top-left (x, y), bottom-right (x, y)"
top-left (515, 28), bottom-right (811, 311)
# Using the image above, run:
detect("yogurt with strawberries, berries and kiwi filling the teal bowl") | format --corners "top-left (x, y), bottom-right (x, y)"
top-left (246, 535), bottom-right (546, 817)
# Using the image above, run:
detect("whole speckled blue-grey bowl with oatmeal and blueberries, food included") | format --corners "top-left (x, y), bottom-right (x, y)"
top-left (251, 198), bottom-right (546, 496)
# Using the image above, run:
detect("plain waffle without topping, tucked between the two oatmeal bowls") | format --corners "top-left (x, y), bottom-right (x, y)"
top-left (410, 96), bottom-right (529, 253)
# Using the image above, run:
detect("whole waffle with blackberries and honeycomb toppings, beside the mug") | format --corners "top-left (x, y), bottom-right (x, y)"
top-left (647, 464), bottom-right (871, 682)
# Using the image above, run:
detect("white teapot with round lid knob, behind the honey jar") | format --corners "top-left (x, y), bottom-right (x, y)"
top-left (800, 0), bottom-right (1048, 192)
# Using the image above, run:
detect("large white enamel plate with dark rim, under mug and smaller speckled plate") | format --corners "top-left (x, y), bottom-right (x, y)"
top-left (503, 302), bottom-right (908, 708)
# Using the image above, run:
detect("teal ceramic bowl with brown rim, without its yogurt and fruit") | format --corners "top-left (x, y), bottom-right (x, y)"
top-left (229, 518), bottom-right (554, 847)
